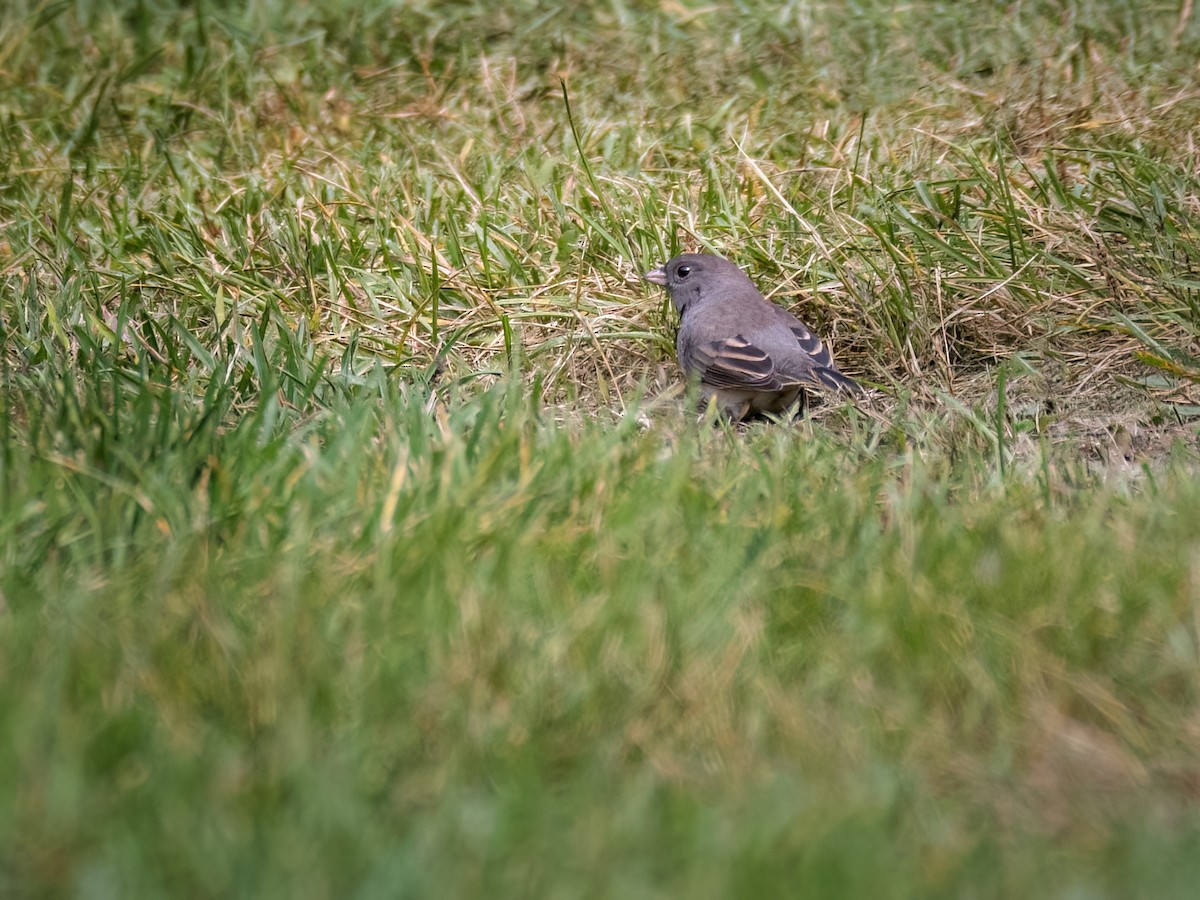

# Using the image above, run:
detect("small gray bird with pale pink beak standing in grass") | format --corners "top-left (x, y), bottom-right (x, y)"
top-left (642, 253), bottom-right (863, 421)
